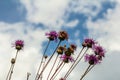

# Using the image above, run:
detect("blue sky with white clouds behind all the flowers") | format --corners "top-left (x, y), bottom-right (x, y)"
top-left (0, 0), bottom-right (120, 80)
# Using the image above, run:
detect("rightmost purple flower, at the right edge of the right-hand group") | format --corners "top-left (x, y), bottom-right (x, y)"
top-left (93, 45), bottom-right (105, 57)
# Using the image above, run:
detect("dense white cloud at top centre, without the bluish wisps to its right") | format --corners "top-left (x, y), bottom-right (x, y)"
top-left (20, 0), bottom-right (70, 28)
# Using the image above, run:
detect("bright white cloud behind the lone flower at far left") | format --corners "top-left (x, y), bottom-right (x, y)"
top-left (0, 22), bottom-right (46, 80)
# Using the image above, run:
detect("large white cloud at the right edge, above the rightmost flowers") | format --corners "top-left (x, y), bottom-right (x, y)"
top-left (87, 4), bottom-right (120, 51)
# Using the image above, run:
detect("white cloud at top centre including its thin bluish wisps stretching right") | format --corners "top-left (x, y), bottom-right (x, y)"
top-left (20, 0), bottom-right (109, 29)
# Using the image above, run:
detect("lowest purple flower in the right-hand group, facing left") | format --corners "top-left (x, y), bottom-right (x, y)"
top-left (85, 54), bottom-right (100, 65)
